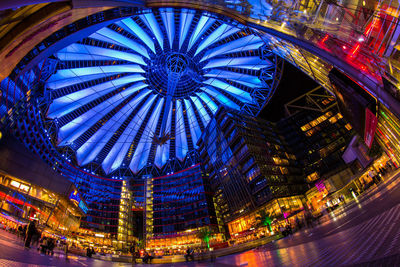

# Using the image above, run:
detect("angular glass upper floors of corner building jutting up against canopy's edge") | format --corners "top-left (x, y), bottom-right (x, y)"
top-left (199, 108), bottom-right (307, 223)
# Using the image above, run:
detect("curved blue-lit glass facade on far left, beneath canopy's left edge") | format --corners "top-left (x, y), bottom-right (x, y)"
top-left (5, 102), bottom-right (123, 246)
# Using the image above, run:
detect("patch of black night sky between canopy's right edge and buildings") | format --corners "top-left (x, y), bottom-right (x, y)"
top-left (258, 62), bottom-right (318, 122)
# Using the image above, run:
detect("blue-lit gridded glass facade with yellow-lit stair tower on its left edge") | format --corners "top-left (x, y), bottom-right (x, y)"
top-left (144, 164), bottom-right (217, 251)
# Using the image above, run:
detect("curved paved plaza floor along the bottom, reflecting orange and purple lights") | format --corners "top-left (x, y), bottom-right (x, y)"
top-left (0, 172), bottom-right (400, 267)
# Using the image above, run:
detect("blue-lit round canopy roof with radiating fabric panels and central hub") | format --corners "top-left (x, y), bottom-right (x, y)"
top-left (46, 8), bottom-right (276, 176)
